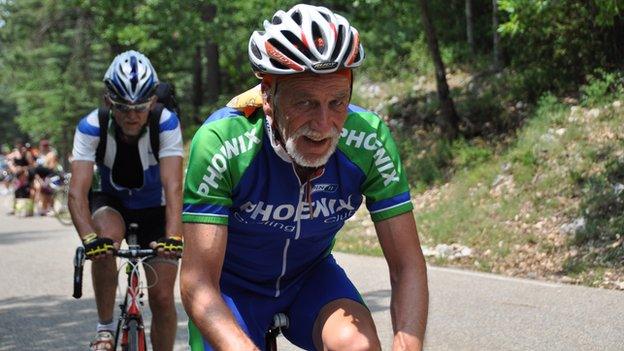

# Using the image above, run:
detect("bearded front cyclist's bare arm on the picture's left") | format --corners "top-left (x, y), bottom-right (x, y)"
top-left (180, 223), bottom-right (258, 350)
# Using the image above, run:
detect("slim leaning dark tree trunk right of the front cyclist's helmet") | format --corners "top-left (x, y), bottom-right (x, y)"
top-left (419, 0), bottom-right (459, 139)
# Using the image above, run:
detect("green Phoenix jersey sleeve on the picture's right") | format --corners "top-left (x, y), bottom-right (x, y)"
top-left (342, 111), bottom-right (414, 222)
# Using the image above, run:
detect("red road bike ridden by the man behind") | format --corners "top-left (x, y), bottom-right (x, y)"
top-left (72, 223), bottom-right (156, 351)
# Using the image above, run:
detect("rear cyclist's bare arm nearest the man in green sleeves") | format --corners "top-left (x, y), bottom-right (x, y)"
top-left (160, 156), bottom-right (182, 237)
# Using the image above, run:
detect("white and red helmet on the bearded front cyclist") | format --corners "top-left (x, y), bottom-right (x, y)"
top-left (248, 4), bottom-right (364, 76)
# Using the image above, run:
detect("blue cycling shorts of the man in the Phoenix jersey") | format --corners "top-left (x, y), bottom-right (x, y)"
top-left (189, 255), bottom-right (364, 351)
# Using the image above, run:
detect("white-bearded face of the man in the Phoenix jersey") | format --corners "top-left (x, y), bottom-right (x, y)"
top-left (273, 73), bottom-right (351, 167)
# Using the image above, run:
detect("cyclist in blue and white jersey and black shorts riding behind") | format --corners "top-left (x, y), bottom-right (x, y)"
top-left (69, 51), bottom-right (183, 350)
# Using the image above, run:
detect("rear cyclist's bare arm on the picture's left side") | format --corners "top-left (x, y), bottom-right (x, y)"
top-left (68, 161), bottom-right (95, 240)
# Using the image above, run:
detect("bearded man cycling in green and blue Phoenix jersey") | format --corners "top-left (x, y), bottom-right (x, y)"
top-left (180, 5), bottom-right (428, 351)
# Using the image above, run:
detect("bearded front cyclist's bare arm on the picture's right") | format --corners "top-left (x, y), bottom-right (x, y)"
top-left (375, 212), bottom-right (429, 350)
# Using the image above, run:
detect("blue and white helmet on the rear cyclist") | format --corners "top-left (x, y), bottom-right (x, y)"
top-left (104, 50), bottom-right (158, 104)
